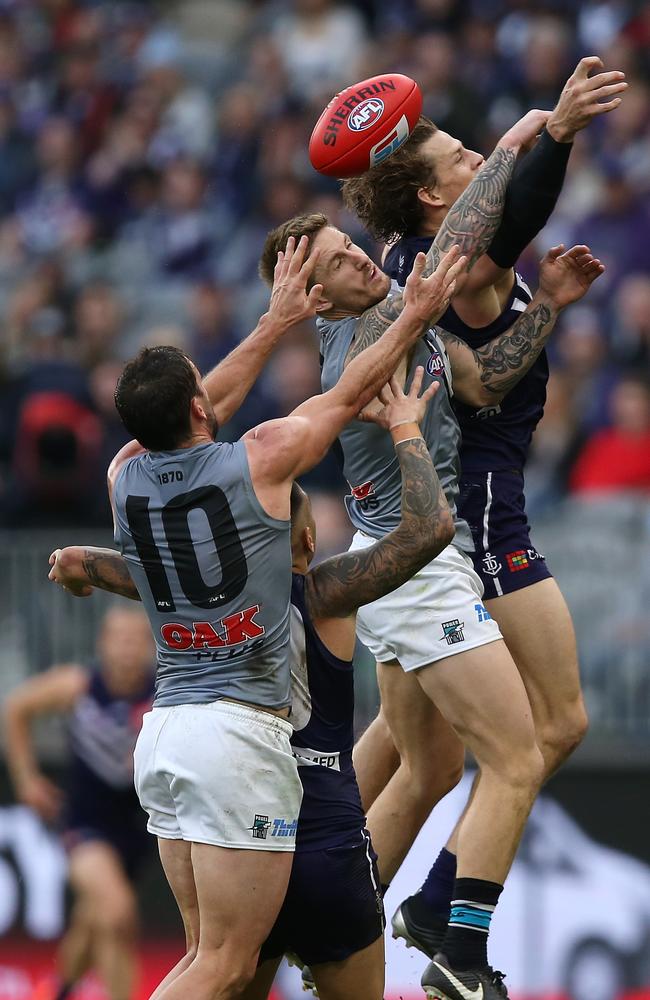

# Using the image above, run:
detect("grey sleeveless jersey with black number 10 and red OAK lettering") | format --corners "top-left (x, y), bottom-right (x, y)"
top-left (113, 441), bottom-right (291, 708)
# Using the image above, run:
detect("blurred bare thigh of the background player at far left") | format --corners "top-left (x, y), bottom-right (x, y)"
top-left (69, 839), bottom-right (137, 922)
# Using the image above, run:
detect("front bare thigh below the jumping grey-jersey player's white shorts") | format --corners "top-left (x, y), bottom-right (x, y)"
top-left (415, 639), bottom-right (535, 769)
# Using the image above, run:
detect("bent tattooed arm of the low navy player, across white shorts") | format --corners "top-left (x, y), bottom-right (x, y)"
top-left (306, 438), bottom-right (454, 618)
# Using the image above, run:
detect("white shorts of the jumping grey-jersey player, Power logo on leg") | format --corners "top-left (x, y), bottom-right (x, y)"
top-left (350, 531), bottom-right (502, 671)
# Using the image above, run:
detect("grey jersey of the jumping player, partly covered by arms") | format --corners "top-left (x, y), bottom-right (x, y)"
top-left (317, 304), bottom-right (474, 552)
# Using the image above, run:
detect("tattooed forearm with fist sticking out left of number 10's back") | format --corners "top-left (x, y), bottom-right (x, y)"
top-left (49, 545), bottom-right (140, 601)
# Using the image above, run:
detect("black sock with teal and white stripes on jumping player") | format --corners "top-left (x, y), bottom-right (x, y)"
top-left (440, 878), bottom-right (503, 972)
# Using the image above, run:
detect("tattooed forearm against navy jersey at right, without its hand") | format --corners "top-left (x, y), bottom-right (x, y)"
top-left (441, 302), bottom-right (558, 402)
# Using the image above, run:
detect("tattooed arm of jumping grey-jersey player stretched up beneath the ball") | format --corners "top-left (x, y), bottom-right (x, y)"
top-left (346, 111), bottom-right (549, 364)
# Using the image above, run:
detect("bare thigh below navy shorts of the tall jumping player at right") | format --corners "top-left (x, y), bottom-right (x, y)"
top-left (486, 577), bottom-right (582, 724)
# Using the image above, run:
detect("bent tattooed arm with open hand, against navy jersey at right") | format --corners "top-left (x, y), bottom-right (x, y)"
top-left (440, 246), bottom-right (605, 407)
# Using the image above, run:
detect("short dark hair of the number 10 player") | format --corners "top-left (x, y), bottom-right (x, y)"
top-left (115, 346), bottom-right (198, 451)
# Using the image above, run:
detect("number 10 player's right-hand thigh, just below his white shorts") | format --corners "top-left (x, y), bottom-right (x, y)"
top-left (192, 843), bottom-right (293, 956)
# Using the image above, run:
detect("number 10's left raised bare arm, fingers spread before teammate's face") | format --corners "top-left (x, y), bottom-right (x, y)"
top-left (203, 236), bottom-right (322, 427)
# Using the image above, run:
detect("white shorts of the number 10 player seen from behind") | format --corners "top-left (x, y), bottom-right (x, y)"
top-left (134, 701), bottom-right (302, 851)
